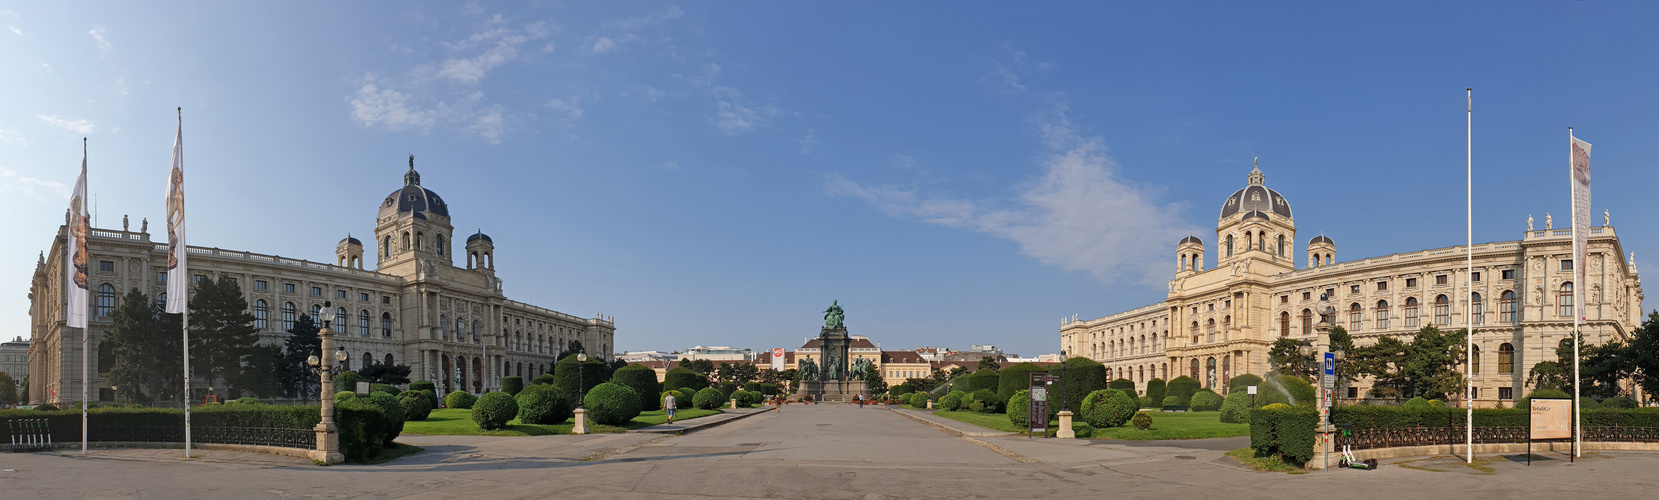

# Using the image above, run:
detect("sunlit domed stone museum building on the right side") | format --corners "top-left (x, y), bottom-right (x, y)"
top-left (1060, 168), bottom-right (1642, 405)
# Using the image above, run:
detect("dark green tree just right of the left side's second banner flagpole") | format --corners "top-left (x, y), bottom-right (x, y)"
top-left (191, 276), bottom-right (264, 394)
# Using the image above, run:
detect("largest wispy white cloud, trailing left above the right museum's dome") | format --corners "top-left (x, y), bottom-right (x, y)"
top-left (825, 105), bottom-right (1191, 282)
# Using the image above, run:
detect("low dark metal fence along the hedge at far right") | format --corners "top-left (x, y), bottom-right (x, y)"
top-left (1335, 425), bottom-right (1659, 450)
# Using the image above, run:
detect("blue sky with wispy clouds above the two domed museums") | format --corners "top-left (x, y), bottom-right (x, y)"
top-left (0, 2), bottom-right (1659, 354)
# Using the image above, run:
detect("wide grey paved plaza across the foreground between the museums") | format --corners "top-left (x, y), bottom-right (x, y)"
top-left (0, 405), bottom-right (1659, 500)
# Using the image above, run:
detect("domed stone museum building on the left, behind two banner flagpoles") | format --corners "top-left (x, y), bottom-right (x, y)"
top-left (28, 158), bottom-right (615, 404)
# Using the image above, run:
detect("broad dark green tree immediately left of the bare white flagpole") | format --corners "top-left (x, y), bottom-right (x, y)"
top-left (1349, 326), bottom-right (1467, 400)
